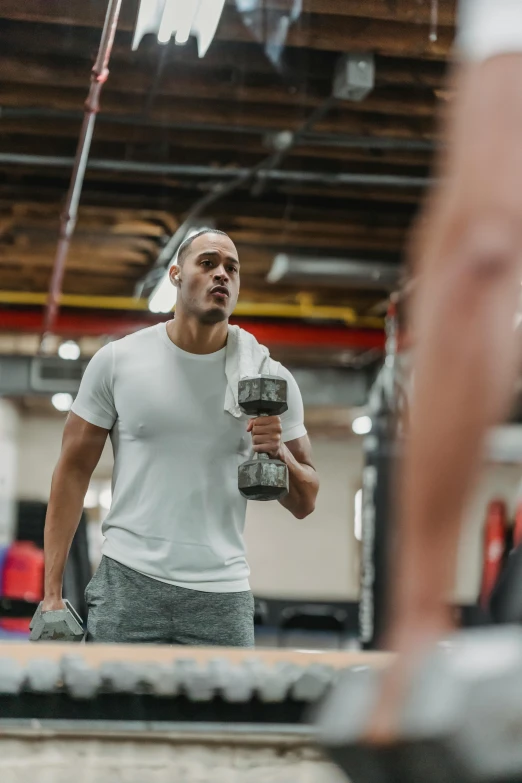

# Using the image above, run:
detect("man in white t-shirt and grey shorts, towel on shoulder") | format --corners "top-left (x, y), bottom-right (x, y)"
top-left (43, 229), bottom-right (319, 647)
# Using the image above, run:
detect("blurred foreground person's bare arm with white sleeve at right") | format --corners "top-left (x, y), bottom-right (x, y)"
top-left (370, 0), bottom-right (522, 742)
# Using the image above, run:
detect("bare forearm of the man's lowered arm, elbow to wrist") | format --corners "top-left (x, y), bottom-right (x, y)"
top-left (44, 463), bottom-right (90, 598)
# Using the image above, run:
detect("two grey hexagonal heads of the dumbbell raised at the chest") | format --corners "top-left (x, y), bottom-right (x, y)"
top-left (238, 375), bottom-right (289, 500)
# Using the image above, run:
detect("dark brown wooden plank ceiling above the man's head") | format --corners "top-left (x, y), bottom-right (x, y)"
top-left (0, 0), bottom-right (455, 340)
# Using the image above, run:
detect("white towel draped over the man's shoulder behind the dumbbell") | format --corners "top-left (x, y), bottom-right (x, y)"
top-left (225, 326), bottom-right (277, 419)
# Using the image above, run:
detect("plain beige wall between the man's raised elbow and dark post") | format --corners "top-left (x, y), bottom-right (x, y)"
top-left (246, 438), bottom-right (363, 600)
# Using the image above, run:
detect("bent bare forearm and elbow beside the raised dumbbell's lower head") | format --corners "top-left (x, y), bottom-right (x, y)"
top-left (279, 435), bottom-right (319, 519)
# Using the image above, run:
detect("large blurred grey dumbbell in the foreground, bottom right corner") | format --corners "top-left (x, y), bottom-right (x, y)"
top-left (316, 627), bottom-right (522, 783)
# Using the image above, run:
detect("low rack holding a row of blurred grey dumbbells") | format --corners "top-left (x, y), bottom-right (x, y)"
top-left (0, 642), bottom-right (388, 726)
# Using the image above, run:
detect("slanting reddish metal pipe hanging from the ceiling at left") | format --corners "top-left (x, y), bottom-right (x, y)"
top-left (40, 0), bottom-right (122, 351)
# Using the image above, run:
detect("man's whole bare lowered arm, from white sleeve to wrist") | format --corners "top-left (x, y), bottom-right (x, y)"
top-left (43, 413), bottom-right (108, 611)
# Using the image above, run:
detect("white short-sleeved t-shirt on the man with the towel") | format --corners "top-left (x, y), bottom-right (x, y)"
top-left (71, 323), bottom-right (306, 593)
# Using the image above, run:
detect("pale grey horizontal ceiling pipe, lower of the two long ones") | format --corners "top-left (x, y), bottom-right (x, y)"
top-left (0, 152), bottom-right (434, 195)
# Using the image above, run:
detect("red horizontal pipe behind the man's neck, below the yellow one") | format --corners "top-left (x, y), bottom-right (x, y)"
top-left (0, 309), bottom-right (384, 350)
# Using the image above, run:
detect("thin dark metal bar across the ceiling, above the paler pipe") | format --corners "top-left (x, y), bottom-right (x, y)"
top-left (0, 106), bottom-right (437, 152)
